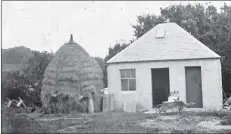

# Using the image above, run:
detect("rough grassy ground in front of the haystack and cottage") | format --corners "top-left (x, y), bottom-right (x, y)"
top-left (2, 106), bottom-right (231, 133)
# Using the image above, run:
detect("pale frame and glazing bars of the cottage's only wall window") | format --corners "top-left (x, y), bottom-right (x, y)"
top-left (120, 68), bottom-right (136, 93)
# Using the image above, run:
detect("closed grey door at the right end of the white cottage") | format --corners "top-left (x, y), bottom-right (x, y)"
top-left (185, 67), bottom-right (203, 108)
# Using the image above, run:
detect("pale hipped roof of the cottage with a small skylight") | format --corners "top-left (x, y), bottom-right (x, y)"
top-left (107, 23), bottom-right (220, 63)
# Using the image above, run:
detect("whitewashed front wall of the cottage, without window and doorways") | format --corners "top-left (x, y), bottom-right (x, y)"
top-left (107, 59), bottom-right (222, 111)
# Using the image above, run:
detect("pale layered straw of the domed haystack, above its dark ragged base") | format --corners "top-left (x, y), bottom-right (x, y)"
top-left (41, 35), bottom-right (104, 111)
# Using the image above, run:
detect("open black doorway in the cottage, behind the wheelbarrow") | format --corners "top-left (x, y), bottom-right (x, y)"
top-left (152, 68), bottom-right (170, 107)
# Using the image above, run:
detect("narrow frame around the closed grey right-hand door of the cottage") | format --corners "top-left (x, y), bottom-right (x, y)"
top-left (184, 66), bottom-right (204, 108)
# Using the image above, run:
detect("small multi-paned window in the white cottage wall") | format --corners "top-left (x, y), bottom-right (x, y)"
top-left (120, 69), bottom-right (136, 91)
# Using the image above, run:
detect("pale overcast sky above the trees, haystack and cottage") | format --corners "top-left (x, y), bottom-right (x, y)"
top-left (2, 1), bottom-right (231, 58)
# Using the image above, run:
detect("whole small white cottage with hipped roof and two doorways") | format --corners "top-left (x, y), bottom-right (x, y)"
top-left (107, 23), bottom-right (222, 112)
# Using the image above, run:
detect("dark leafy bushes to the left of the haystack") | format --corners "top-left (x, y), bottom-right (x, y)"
top-left (2, 51), bottom-right (52, 106)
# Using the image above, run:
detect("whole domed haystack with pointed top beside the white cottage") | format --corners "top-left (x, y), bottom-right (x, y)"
top-left (41, 35), bottom-right (104, 113)
